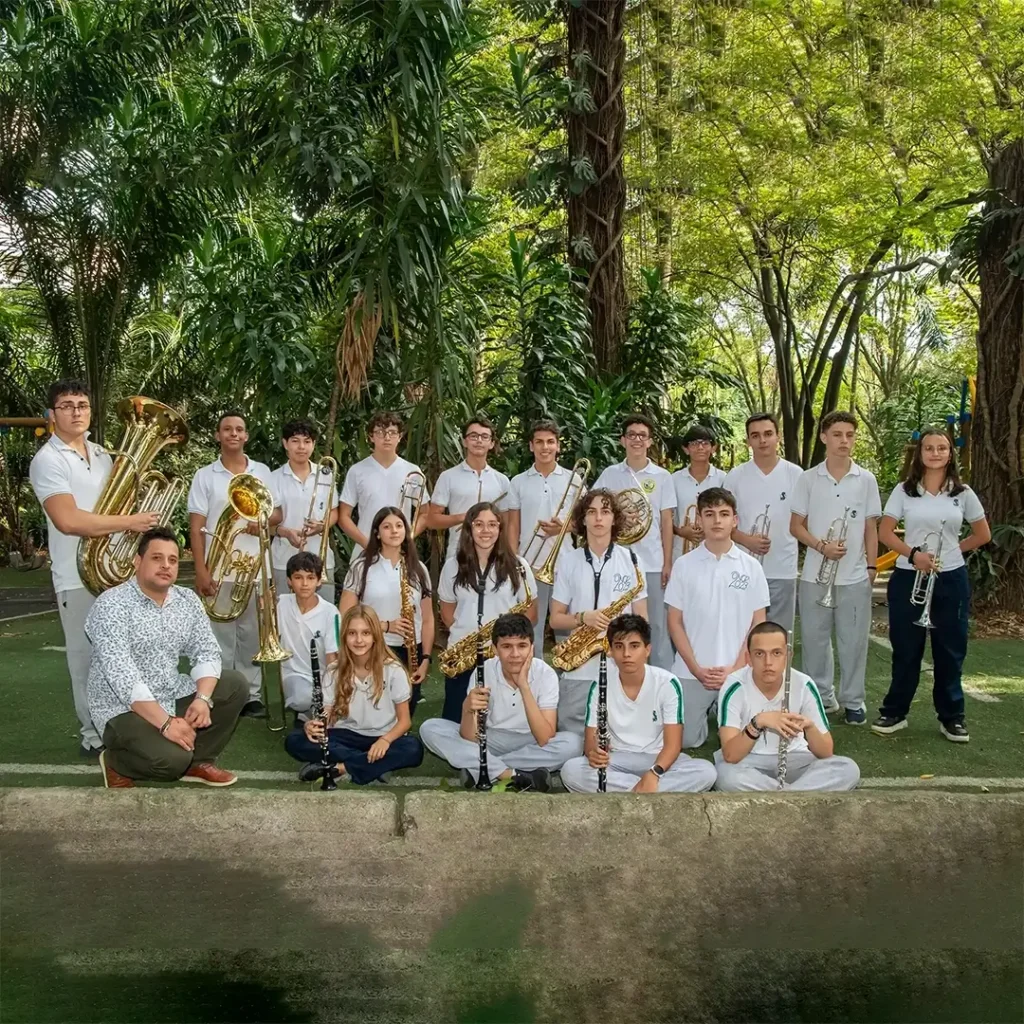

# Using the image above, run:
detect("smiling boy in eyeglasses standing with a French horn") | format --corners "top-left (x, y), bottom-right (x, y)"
top-left (594, 414), bottom-right (676, 669)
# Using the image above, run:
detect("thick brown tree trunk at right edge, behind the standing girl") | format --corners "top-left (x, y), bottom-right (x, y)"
top-left (972, 139), bottom-right (1024, 611)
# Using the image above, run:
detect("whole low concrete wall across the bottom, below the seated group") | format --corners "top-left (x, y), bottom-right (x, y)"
top-left (0, 787), bottom-right (1024, 1022)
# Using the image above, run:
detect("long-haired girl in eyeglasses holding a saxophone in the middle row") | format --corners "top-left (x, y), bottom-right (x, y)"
top-left (437, 502), bottom-right (537, 722)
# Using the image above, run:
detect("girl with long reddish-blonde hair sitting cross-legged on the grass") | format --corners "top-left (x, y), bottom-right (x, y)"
top-left (285, 604), bottom-right (423, 785)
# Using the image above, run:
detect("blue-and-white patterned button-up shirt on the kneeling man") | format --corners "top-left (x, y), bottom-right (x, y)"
top-left (85, 580), bottom-right (220, 736)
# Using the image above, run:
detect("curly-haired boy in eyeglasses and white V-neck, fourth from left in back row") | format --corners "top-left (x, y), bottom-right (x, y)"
top-left (338, 413), bottom-right (430, 561)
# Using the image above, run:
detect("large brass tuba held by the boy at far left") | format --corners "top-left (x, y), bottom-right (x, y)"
top-left (78, 394), bottom-right (188, 595)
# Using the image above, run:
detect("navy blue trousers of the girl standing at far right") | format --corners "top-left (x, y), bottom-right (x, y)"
top-left (881, 565), bottom-right (971, 722)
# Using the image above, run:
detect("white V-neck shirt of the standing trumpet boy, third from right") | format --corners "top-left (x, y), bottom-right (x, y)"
top-left (722, 459), bottom-right (804, 580)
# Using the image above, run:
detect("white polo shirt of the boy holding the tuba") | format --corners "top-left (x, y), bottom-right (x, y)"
top-left (29, 433), bottom-right (114, 594)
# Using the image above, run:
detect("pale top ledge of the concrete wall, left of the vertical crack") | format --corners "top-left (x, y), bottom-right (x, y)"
top-left (0, 785), bottom-right (398, 837)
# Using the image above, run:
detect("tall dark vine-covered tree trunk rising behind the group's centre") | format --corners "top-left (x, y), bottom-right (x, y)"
top-left (567, 0), bottom-right (626, 373)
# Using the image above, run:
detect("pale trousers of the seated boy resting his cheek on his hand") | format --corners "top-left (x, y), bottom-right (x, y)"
top-left (420, 718), bottom-right (583, 779)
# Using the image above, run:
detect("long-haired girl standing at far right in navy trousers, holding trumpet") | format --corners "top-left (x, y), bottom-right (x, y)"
top-left (871, 427), bottom-right (992, 743)
